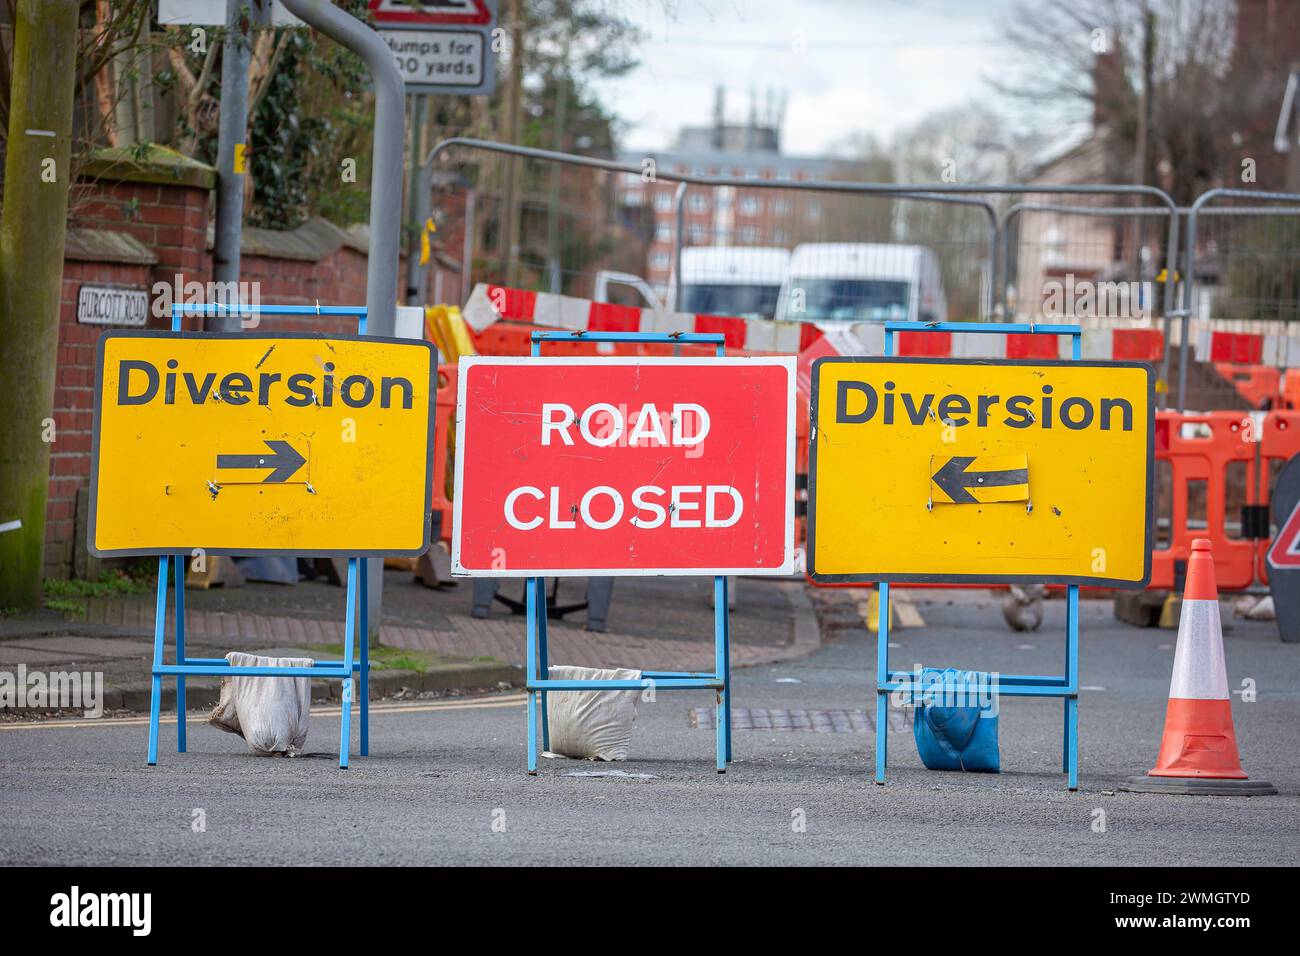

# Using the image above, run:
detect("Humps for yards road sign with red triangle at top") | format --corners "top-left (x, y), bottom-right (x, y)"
top-left (369, 0), bottom-right (497, 96)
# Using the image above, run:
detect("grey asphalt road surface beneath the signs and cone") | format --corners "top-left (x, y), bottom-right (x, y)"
top-left (0, 600), bottom-right (1300, 866)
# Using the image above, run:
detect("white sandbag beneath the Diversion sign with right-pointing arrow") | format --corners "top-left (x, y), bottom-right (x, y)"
top-left (208, 650), bottom-right (312, 756)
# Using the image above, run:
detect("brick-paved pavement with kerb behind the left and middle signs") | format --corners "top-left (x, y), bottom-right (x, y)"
top-left (0, 570), bottom-right (818, 709)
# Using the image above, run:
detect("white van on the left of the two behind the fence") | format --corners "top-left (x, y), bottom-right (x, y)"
top-left (668, 246), bottom-right (790, 319)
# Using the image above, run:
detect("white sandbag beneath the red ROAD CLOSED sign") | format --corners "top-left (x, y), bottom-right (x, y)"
top-left (546, 666), bottom-right (641, 760)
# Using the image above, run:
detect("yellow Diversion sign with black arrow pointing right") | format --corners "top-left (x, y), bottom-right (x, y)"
top-left (88, 332), bottom-right (436, 555)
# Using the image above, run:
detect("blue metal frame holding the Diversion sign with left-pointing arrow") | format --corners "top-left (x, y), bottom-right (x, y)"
top-left (876, 321), bottom-right (1083, 791)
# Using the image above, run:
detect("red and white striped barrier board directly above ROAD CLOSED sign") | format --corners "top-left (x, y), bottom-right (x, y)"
top-left (462, 284), bottom-right (803, 354)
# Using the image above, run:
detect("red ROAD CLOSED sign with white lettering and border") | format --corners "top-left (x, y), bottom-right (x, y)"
top-left (451, 356), bottom-right (794, 578)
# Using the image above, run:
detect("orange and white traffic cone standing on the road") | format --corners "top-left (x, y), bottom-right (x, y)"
top-left (1121, 537), bottom-right (1278, 796)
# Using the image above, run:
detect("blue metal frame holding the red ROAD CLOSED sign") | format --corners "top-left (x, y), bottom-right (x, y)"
top-left (525, 332), bottom-right (732, 777)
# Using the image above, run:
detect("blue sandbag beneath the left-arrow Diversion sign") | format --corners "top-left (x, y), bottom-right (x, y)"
top-left (913, 667), bottom-right (1000, 774)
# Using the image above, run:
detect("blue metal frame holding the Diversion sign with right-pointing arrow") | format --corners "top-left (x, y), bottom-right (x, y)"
top-left (148, 303), bottom-right (371, 770)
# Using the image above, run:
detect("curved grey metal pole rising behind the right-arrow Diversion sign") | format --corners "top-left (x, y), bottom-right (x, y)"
top-left (281, 0), bottom-right (406, 644)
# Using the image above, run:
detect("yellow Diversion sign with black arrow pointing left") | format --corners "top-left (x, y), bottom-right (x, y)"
top-left (809, 358), bottom-right (1154, 587)
